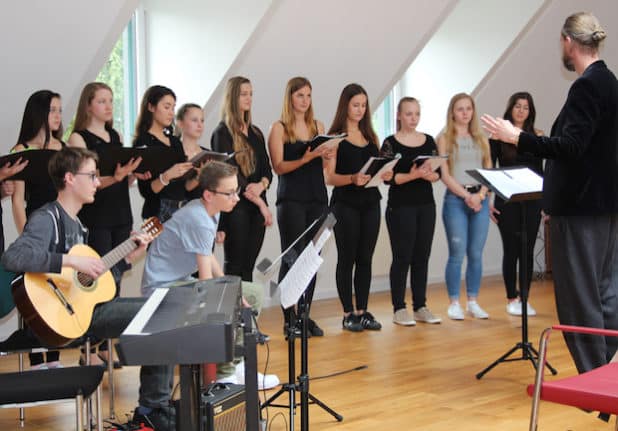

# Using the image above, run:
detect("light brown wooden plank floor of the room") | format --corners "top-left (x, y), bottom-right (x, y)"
top-left (0, 277), bottom-right (613, 431)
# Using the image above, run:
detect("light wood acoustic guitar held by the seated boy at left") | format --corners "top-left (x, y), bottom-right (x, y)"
top-left (12, 217), bottom-right (163, 346)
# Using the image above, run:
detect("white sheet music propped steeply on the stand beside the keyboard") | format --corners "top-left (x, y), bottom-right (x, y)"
top-left (279, 238), bottom-right (324, 308)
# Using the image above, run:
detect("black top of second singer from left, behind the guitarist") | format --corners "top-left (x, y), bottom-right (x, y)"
top-left (75, 129), bottom-right (133, 228)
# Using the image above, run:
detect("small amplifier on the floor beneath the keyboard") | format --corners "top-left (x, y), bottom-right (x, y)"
top-left (202, 383), bottom-right (247, 431)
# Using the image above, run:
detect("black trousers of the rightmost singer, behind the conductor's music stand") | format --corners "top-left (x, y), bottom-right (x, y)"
top-left (495, 200), bottom-right (541, 299)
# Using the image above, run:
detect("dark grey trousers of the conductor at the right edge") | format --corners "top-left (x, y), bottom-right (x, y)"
top-left (549, 214), bottom-right (618, 373)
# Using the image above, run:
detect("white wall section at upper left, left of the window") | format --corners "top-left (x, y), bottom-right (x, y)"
top-left (0, 0), bottom-right (138, 147)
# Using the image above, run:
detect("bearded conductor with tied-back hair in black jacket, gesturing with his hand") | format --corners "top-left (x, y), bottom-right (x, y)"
top-left (482, 12), bottom-right (618, 373)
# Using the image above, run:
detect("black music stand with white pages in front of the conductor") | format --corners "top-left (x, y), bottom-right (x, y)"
top-left (466, 167), bottom-right (558, 380)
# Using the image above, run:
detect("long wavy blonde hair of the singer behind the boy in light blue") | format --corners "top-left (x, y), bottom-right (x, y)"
top-left (221, 76), bottom-right (255, 177)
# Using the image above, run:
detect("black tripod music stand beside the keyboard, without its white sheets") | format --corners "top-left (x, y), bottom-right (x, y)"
top-left (258, 213), bottom-right (343, 431)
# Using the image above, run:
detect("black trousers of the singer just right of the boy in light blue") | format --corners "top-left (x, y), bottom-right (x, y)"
top-left (222, 200), bottom-right (266, 281)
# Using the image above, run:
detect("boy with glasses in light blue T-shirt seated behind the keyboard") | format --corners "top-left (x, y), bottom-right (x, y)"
top-left (135, 161), bottom-right (279, 428)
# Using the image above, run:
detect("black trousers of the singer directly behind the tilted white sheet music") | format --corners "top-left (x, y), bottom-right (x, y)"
top-left (277, 201), bottom-right (328, 322)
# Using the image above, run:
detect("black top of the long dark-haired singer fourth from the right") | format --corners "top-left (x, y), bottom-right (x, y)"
top-left (330, 139), bottom-right (382, 208)
